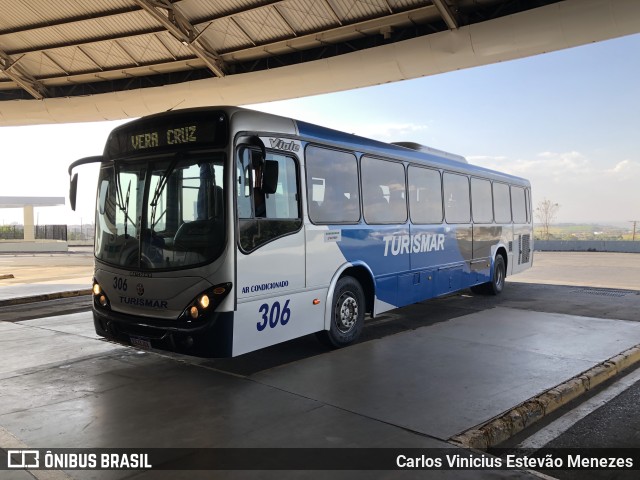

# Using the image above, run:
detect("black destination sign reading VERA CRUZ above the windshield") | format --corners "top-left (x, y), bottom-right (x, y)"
top-left (105, 110), bottom-right (228, 158)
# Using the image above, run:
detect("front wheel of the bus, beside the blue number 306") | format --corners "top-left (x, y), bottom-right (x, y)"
top-left (318, 277), bottom-right (365, 348)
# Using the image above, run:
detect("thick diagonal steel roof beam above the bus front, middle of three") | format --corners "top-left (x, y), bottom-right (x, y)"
top-left (134, 0), bottom-right (225, 77)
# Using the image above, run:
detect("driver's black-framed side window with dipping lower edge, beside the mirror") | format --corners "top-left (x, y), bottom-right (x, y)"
top-left (236, 148), bottom-right (302, 252)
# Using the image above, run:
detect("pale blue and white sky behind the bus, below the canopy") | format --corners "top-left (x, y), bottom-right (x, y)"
top-left (0, 34), bottom-right (640, 226)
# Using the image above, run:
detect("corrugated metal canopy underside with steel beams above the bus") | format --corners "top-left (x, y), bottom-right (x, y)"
top-left (0, 0), bottom-right (557, 100)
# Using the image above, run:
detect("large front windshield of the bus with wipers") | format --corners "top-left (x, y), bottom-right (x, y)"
top-left (95, 153), bottom-right (226, 271)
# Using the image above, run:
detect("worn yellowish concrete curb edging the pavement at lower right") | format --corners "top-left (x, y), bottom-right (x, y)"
top-left (449, 345), bottom-right (640, 450)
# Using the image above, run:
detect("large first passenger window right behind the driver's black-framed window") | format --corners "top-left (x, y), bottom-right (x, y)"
top-left (306, 146), bottom-right (360, 223)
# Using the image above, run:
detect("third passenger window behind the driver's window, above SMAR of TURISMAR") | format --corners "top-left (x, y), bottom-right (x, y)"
top-left (409, 166), bottom-right (442, 224)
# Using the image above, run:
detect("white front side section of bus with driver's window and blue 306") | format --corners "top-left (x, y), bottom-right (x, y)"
top-left (232, 151), bottom-right (323, 356)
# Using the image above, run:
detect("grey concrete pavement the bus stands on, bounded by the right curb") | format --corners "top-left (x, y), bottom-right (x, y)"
top-left (0, 249), bottom-right (640, 479)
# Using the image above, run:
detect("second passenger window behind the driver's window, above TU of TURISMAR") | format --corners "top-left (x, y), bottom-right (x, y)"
top-left (361, 157), bottom-right (407, 224)
